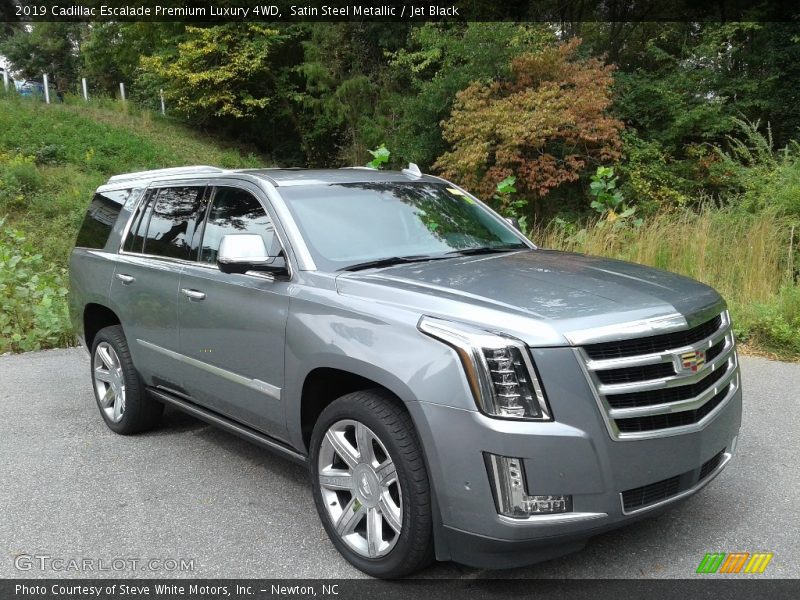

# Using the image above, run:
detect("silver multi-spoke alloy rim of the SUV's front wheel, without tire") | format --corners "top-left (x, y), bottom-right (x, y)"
top-left (318, 420), bottom-right (403, 558)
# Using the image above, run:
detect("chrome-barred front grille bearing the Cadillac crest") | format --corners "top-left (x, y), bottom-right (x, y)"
top-left (577, 312), bottom-right (739, 439)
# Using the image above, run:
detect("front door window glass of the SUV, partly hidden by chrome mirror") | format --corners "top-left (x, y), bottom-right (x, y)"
top-left (200, 187), bottom-right (275, 263)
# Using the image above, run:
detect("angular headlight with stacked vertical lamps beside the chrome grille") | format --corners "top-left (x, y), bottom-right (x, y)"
top-left (418, 317), bottom-right (551, 421)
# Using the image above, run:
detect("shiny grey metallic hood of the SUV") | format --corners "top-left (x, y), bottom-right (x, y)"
top-left (337, 250), bottom-right (723, 345)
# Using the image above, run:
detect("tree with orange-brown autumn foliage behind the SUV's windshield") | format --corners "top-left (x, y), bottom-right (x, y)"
top-left (435, 39), bottom-right (623, 206)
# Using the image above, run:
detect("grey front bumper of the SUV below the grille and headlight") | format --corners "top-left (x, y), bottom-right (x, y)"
top-left (412, 348), bottom-right (741, 568)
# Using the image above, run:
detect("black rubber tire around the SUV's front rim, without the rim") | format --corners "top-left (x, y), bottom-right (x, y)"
top-left (309, 389), bottom-right (434, 578)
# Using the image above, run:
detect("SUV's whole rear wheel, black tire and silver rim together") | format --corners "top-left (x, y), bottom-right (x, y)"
top-left (92, 325), bottom-right (164, 435)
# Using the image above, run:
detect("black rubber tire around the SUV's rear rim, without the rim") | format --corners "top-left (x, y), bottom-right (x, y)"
top-left (89, 325), bottom-right (164, 435)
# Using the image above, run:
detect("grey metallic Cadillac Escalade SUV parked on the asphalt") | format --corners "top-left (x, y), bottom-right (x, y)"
top-left (70, 165), bottom-right (741, 577)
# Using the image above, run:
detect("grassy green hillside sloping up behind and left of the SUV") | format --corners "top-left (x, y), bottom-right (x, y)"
top-left (0, 94), bottom-right (263, 354)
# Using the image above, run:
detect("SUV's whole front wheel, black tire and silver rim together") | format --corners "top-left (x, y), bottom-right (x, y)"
top-left (310, 390), bottom-right (433, 578)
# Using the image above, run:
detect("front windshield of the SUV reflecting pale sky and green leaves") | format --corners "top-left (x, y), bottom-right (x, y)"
top-left (280, 182), bottom-right (528, 271)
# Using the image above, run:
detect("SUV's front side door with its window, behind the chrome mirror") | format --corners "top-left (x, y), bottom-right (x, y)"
top-left (178, 180), bottom-right (290, 439)
